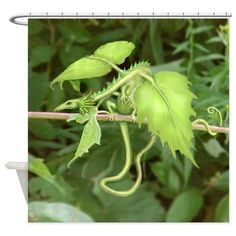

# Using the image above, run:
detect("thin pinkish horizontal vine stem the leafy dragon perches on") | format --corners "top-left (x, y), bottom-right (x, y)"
top-left (28, 111), bottom-right (229, 134)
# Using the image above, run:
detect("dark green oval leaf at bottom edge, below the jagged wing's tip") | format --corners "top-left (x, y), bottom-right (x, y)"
top-left (166, 189), bottom-right (203, 222)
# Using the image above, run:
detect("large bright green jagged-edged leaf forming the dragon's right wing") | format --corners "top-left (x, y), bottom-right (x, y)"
top-left (134, 71), bottom-right (197, 166)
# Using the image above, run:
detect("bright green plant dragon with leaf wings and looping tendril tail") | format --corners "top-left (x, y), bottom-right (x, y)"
top-left (51, 41), bottom-right (222, 197)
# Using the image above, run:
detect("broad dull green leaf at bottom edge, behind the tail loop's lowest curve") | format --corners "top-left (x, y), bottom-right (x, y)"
top-left (96, 179), bottom-right (164, 222)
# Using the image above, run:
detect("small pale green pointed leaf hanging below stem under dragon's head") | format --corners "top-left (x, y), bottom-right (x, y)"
top-left (68, 112), bottom-right (101, 166)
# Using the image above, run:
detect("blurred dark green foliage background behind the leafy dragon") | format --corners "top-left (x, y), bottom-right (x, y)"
top-left (28, 19), bottom-right (229, 222)
